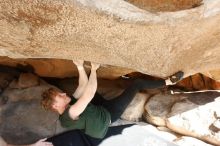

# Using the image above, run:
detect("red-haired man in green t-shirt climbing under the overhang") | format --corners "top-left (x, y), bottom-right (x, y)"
top-left (41, 61), bottom-right (183, 138)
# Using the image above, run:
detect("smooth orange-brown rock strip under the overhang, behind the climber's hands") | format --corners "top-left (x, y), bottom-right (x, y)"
top-left (0, 57), bottom-right (134, 79)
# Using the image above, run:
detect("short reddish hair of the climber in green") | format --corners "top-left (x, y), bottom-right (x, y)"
top-left (41, 88), bottom-right (60, 111)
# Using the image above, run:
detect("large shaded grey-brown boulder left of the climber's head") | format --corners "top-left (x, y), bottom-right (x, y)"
top-left (0, 74), bottom-right (64, 144)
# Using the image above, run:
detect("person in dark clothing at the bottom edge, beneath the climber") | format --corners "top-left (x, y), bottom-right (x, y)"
top-left (0, 124), bottom-right (135, 146)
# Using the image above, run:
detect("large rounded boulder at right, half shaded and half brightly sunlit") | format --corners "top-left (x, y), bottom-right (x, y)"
top-left (145, 92), bottom-right (220, 145)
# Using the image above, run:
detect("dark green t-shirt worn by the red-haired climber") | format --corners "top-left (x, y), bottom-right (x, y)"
top-left (59, 98), bottom-right (111, 138)
